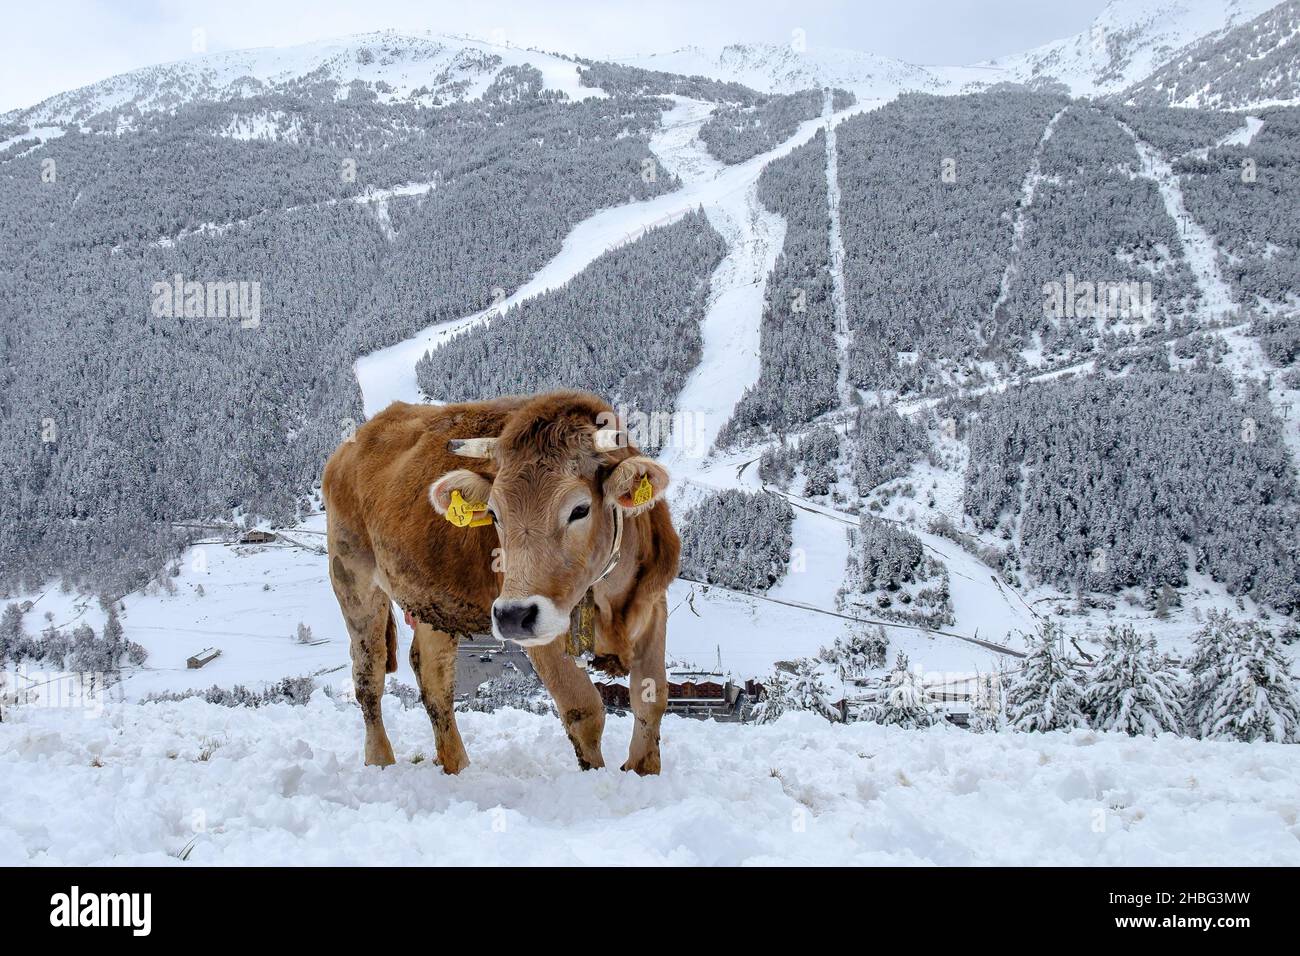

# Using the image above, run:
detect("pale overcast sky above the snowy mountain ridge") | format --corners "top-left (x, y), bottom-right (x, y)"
top-left (0, 0), bottom-right (1105, 111)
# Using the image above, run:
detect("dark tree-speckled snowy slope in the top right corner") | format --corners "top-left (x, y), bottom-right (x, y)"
top-left (1119, 0), bottom-right (1300, 109)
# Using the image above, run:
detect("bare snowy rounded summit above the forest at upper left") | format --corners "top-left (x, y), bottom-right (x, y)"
top-left (3, 31), bottom-right (603, 126)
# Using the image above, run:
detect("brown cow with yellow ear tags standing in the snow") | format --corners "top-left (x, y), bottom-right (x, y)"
top-left (322, 392), bottom-right (679, 774)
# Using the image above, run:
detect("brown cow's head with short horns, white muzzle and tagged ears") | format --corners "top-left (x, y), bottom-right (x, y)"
top-left (429, 393), bottom-right (668, 645)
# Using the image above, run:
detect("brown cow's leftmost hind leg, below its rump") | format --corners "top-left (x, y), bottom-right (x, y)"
top-left (329, 554), bottom-right (397, 766)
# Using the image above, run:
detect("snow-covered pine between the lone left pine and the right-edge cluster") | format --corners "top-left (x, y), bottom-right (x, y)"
top-left (1084, 624), bottom-right (1183, 736)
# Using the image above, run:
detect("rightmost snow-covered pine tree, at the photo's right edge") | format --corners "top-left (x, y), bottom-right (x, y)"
top-left (1187, 613), bottom-right (1300, 743)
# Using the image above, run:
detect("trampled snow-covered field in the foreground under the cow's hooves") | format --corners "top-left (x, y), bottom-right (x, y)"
top-left (0, 692), bottom-right (1300, 865)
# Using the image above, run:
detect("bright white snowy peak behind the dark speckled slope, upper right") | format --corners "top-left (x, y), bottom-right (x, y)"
top-left (980, 0), bottom-right (1277, 96)
